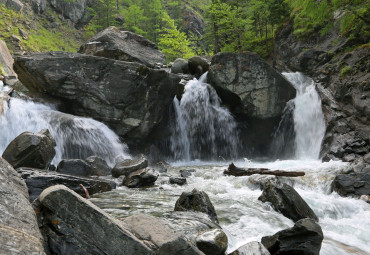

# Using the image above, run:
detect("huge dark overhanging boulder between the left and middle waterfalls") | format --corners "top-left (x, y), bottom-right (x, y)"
top-left (15, 52), bottom-right (180, 150)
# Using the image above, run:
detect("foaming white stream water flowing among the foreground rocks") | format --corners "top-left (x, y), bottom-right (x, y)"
top-left (91, 160), bottom-right (370, 255)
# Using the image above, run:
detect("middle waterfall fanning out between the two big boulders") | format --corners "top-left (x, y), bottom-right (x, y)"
top-left (171, 73), bottom-right (238, 160)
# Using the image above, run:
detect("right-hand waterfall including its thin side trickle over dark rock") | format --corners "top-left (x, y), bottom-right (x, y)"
top-left (272, 72), bottom-right (326, 159)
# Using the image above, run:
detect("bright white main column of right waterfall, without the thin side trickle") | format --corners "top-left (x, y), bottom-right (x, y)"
top-left (283, 72), bottom-right (326, 159)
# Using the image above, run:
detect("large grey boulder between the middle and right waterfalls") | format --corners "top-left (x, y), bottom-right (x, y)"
top-left (208, 52), bottom-right (296, 119)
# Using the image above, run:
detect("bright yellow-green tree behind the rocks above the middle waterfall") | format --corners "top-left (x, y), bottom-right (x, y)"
top-left (158, 12), bottom-right (194, 62)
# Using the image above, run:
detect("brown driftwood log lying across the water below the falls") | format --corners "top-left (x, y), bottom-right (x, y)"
top-left (224, 163), bottom-right (305, 177)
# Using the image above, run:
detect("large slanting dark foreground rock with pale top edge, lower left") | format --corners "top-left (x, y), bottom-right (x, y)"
top-left (34, 185), bottom-right (154, 255)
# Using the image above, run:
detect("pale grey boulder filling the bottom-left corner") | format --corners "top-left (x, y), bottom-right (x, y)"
top-left (0, 157), bottom-right (45, 255)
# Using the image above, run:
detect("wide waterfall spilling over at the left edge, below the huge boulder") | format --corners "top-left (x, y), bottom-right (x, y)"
top-left (0, 98), bottom-right (130, 166)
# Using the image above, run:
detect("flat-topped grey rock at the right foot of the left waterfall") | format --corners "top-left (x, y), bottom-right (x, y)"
top-left (112, 155), bottom-right (148, 178)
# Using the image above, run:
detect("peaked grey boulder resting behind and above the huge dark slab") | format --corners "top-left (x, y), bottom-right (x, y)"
top-left (79, 26), bottom-right (166, 67)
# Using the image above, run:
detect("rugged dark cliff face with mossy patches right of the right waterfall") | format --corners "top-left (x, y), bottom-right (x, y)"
top-left (274, 21), bottom-right (370, 161)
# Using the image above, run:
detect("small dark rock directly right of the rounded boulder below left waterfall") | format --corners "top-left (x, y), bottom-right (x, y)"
top-left (57, 159), bottom-right (93, 176)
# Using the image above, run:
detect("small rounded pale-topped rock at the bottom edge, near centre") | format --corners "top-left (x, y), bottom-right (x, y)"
top-left (196, 229), bottom-right (228, 255)
